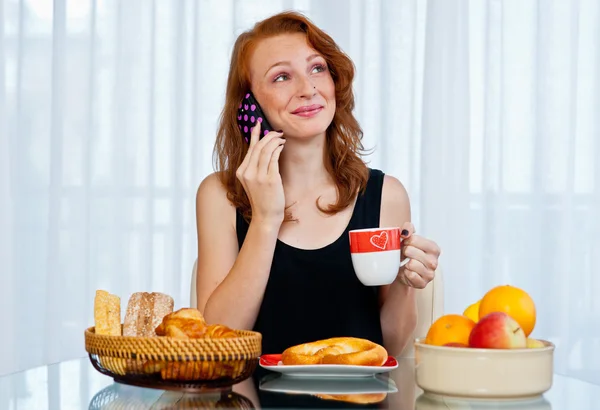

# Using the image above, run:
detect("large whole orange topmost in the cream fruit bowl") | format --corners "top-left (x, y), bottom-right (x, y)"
top-left (479, 285), bottom-right (536, 336)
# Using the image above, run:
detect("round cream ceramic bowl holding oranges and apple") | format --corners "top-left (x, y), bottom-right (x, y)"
top-left (415, 338), bottom-right (554, 400)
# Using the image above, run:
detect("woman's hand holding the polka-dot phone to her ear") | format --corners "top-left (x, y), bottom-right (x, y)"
top-left (236, 123), bottom-right (285, 229)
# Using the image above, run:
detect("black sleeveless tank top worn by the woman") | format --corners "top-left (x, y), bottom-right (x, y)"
top-left (236, 169), bottom-right (384, 353)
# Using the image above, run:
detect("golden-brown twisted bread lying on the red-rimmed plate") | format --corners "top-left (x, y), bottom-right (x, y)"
top-left (281, 337), bottom-right (388, 366)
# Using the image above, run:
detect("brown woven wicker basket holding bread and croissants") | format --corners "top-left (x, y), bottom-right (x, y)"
top-left (85, 327), bottom-right (262, 390)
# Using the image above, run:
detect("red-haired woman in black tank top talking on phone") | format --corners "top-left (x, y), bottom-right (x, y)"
top-left (196, 12), bottom-right (440, 362)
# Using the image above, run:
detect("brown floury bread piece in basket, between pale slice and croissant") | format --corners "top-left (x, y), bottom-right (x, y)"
top-left (123, 292), bottom-right (174, 337)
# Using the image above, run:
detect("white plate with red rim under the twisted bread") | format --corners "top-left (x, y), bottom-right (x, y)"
top-left (258, 354), bottom-right (398, 378)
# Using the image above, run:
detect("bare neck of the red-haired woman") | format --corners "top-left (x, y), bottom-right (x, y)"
top-left (279, 134), bottom-right (332, 193)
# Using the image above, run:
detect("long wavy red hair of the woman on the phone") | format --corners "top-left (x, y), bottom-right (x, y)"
top-left (214, 12), bottom-right (369, 221)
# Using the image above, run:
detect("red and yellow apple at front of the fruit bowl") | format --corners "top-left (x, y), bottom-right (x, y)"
top-left (469, 312), bottom-right (527, 349)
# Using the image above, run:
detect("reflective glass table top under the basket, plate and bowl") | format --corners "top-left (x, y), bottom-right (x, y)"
top-left (0, 357), bottom-right (600, 410)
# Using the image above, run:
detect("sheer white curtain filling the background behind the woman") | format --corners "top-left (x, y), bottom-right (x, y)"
top-left (0, 0), bottom-right (600, 388)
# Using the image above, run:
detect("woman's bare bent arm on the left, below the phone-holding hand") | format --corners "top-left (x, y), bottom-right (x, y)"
top-left (196, 174), bottom-right (278, 329)
